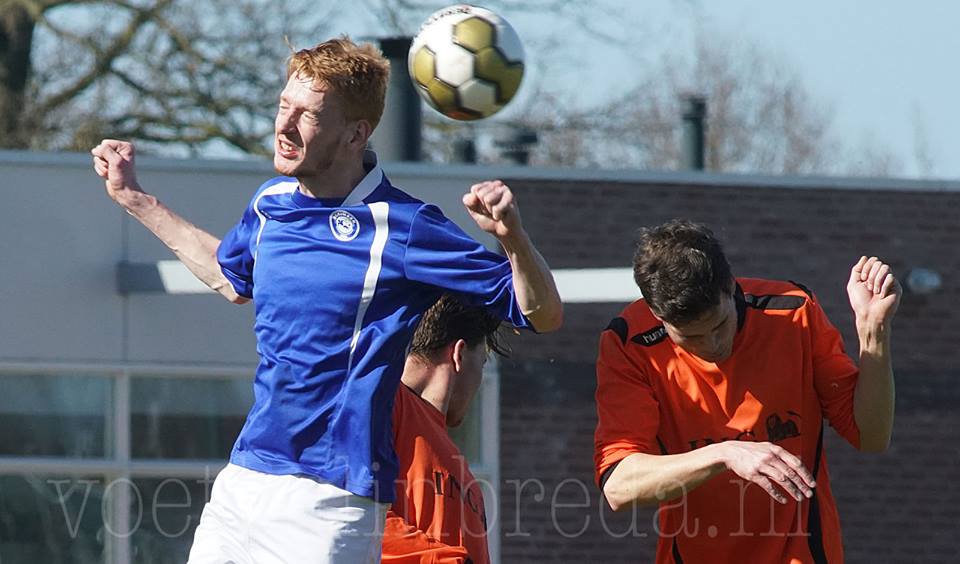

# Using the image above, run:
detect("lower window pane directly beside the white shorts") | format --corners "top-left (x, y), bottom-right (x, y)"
top-left (130, 476), bottom-right (213, 564)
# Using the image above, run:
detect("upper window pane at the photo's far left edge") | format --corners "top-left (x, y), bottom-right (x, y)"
top-left (0, 374), bottom-right (112, 458)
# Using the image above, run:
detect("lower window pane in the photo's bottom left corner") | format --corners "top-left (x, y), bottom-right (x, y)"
top-left (0, 476), bottom-right (110, 564)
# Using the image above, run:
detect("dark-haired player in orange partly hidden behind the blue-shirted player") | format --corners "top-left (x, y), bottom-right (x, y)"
top-left (383, 295), bottom-right (503, 564)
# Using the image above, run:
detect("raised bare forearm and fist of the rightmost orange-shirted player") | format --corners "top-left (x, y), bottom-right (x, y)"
top-left (847, 257), bottom-right (903, 452)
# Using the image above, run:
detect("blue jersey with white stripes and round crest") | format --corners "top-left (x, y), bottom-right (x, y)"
top-left (217, 153), bottom-right (529, 502)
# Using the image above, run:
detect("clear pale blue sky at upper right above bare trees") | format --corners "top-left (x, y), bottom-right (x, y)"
top-left (356, 0), bottom-right (960, 178)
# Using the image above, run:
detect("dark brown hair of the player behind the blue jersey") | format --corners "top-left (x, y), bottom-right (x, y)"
top-left (410, 294), bottom-right (507, 359)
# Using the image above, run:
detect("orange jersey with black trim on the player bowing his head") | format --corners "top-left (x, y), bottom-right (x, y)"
top-left (594, 279), bottom-right (860, 564)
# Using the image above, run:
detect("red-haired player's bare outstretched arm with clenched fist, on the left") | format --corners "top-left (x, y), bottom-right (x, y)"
top-left (90, 139), bottom-right (249, 303)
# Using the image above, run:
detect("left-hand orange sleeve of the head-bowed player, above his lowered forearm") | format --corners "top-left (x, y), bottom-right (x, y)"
top-left (594, 324), bottom-right (660, 485)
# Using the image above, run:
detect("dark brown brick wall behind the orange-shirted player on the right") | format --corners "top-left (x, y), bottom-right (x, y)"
top-left (498, 180), bottom-right (960, 563)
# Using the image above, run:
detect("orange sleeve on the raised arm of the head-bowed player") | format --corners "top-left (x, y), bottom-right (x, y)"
top-left (807, 300), bottom-right (860, 448)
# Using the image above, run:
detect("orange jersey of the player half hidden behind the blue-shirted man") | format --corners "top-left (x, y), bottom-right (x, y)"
top-left (383, 385), bottom-right (489, 564)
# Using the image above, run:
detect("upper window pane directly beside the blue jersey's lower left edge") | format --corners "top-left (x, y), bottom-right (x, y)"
top-left (130, 377), bottom-right (253, 459)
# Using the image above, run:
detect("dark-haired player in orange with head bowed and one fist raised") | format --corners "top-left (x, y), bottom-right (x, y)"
top-left (595, 221), bottom-right (901, 563)
